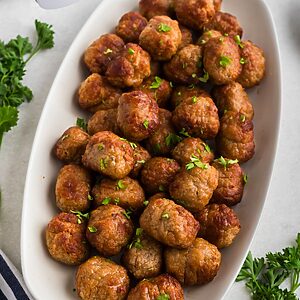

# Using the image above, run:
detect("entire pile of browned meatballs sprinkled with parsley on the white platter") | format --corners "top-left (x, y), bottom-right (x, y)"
top-left (46, 0), bottom-right (265, 300)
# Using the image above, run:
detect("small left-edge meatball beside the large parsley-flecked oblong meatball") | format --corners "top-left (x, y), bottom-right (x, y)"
top-left (54, 126), bottom-right (90, 163)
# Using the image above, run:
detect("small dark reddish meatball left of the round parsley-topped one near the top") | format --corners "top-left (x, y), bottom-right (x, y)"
top-left (116, 11), bottom-right (148, 43)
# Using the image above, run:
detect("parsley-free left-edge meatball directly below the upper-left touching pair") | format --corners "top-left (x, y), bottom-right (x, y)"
top-left (78, 73), bottom-right (121, 112)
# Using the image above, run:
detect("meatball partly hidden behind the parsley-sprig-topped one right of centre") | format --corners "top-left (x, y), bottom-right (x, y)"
top-left (172, 137), bottom-right (214, 166)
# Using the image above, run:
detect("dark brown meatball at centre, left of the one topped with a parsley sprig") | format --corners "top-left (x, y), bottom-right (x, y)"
top-left (141, 157), bottom-right (180, 194)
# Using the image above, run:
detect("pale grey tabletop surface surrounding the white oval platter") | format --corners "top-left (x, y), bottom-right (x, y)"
top-left (0, 0), bottom-right (300, 300)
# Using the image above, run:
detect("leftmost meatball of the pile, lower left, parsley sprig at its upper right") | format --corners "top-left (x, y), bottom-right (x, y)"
top-left (46, 213), bottom-right (89, 265)
